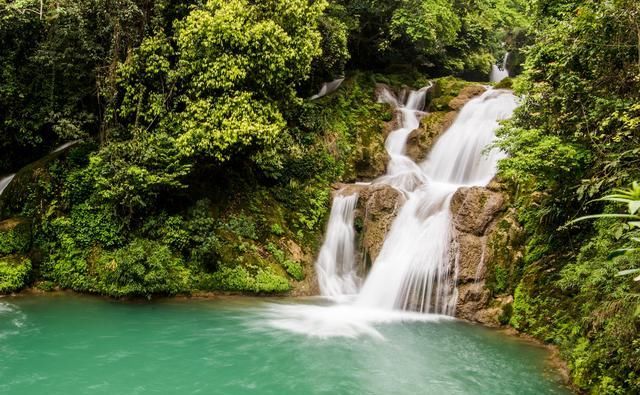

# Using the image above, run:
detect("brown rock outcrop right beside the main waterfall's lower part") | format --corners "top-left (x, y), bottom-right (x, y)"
top-left (451, 183), bottom-right (522, 326)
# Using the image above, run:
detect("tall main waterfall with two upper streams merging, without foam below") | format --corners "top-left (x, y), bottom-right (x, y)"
top-left (356, 90), bottom-right (517, 315)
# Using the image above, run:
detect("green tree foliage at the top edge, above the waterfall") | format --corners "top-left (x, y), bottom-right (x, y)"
top-left (339, 0), bottom-right (529, 76)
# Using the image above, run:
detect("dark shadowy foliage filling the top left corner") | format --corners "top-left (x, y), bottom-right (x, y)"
top-left (0, 0), bottom-right (190, 173)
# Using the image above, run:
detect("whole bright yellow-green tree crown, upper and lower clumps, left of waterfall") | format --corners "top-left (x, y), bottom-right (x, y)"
top-left (110, 0), bottom-right (326, 176)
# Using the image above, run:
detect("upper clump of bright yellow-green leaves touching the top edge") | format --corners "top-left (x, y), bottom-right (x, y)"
top-left (176, 0), bottom-right (325, 99)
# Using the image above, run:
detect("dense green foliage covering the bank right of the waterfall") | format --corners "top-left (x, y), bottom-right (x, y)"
top-left (500, 0), bottom-right (640, 394)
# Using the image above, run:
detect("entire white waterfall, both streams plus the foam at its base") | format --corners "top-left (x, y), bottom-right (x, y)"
top-left (266, 85), bottom-right (517, 337)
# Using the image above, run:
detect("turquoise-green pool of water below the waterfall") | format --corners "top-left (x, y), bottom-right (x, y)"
top-left (0, 295), bottom-right (568, 395)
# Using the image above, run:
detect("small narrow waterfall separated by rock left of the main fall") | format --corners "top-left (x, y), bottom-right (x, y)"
top-left (316, 192), bottom-right (361, 297)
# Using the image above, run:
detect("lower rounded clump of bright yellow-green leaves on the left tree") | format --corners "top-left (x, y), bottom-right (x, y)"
top-left (178, 92), bottom-right (285, 162)
